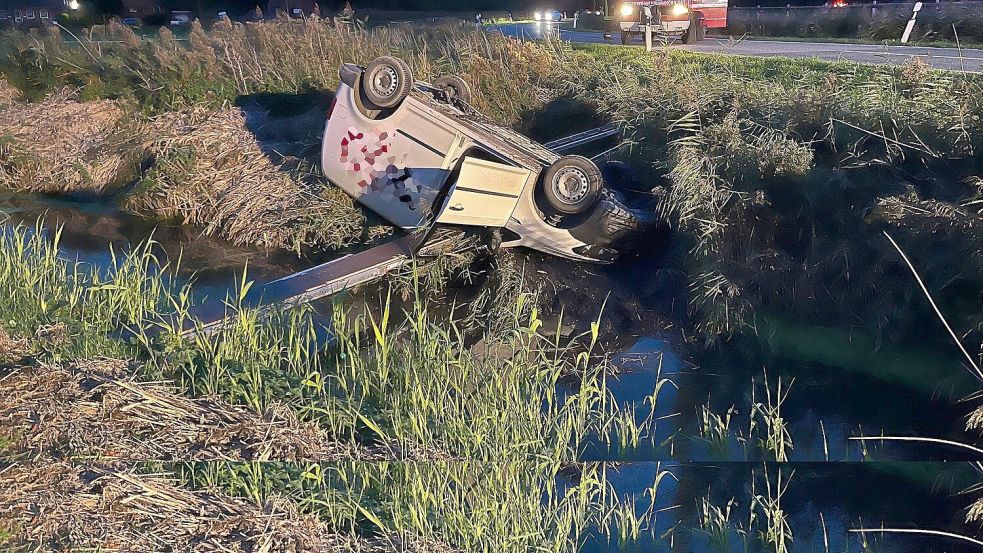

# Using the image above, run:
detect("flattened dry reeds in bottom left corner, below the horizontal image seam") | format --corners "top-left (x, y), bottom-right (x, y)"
top-left (0, 463), bottom-right (395, 553)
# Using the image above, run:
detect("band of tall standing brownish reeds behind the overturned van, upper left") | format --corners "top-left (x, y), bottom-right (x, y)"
top-left (0, 17), bottom-right (560, 123)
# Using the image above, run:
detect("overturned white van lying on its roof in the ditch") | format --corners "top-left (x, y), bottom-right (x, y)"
top-left (321, 56), bottom-right (644, 263)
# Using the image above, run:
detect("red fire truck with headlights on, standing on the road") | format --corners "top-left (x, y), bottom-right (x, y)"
top-left (618, 0), bottom-right (727, 44)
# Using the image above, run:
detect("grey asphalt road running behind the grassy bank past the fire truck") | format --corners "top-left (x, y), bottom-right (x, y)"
top-left (496, 23), bottom-right (983, 72)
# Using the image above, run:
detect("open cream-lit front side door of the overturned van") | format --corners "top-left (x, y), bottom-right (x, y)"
top-left (437, 157), bottom-right (531, 227)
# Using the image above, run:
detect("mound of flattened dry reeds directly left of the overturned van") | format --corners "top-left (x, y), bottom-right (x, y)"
top-left (125, 108), bottom-right (364, 251)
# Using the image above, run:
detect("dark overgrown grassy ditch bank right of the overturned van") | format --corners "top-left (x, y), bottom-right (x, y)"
top-left (568, 42), bottom-right (983, 462)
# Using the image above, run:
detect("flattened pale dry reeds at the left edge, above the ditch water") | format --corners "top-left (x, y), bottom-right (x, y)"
top-left (0, 92), bottom-right (142, 195)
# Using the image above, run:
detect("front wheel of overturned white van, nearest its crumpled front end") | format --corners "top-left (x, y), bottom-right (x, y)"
top-left (542, 156), bottom-right (603, 215)
